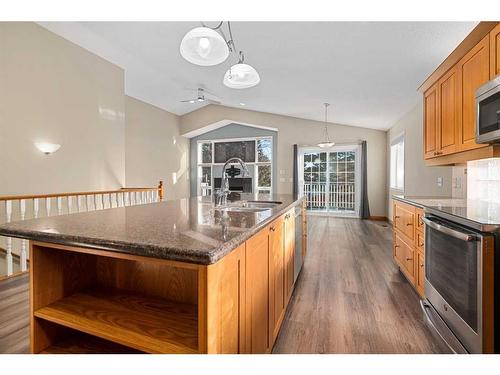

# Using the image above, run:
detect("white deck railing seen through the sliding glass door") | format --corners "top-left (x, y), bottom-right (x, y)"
top-left (303, 182), bottom-right (356, 211)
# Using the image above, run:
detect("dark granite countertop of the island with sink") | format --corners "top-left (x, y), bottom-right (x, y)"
top-left (0, 194), bottom-right (302, 264)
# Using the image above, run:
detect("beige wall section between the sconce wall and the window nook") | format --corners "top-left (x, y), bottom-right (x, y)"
top-left (125, 96), bottom-right (189, 200)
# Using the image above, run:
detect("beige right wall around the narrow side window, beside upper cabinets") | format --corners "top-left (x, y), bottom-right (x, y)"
top-left (387, 102), bottom-right (452, 220)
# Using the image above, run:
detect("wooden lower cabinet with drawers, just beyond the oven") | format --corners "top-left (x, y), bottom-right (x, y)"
top-left (393, 200), bottom-right (425, 298)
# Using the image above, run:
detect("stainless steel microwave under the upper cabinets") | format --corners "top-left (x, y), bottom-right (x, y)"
top-left (476, 76), bottom-right (500, 143)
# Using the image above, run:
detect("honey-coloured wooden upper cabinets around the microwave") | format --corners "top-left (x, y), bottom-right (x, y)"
top-left (422, 22), bottom-right (500, 165)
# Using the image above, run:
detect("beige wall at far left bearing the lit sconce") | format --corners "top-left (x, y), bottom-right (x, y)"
top-left (0, 22), bottom-right (125, 195)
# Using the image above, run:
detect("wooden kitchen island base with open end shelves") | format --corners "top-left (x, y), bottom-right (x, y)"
top-left (30, 204), bottom-right (306, 354)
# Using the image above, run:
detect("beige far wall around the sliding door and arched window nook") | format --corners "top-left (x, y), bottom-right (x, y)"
top-left (181, 105), bottom-right (387, 216)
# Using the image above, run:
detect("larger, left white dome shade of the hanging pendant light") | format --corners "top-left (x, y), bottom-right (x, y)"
top-left (180, 27), bottom-right (229, 66)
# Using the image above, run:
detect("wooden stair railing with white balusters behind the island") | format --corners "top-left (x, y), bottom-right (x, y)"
top-left (0, 181), bottom-right (164, 277)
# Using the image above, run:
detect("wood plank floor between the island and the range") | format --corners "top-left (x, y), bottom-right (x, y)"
top-left (273, 216), bottom-right (448, 353)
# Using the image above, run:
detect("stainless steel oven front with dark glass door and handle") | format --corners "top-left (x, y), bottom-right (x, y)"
top-left (423, 216), bottom-right (483, 353)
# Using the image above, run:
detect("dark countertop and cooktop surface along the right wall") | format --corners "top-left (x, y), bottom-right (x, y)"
top-left (392, 195), bottom-right (500, 232)
